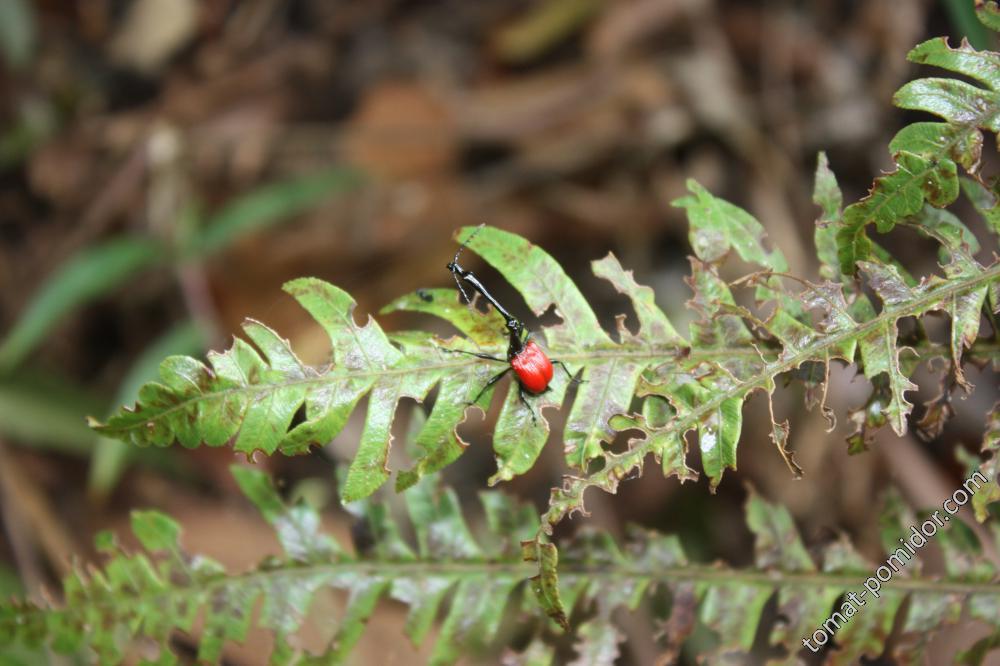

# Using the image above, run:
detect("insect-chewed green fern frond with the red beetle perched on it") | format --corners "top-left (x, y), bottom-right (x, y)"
top-left (96, 215), bottom-right (1000, 496)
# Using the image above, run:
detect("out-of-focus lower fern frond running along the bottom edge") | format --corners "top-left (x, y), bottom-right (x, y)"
top-left (0, 467), bottom-right (1000, 664)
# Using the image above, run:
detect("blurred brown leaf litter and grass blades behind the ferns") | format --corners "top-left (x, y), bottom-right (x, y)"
top-left (0, 0), bottom-right (998, 663)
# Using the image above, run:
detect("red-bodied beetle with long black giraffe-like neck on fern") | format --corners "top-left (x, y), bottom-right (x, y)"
top-left (446, 224), bottom-right (581, 421)
